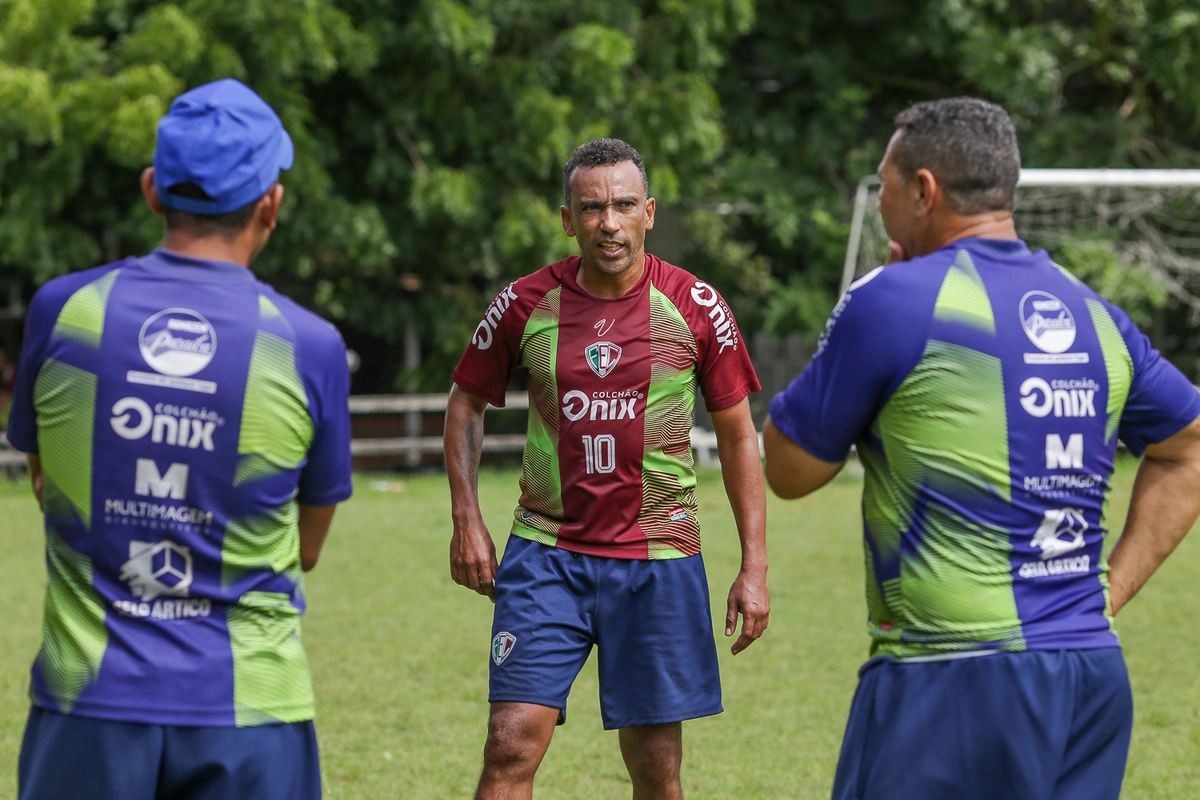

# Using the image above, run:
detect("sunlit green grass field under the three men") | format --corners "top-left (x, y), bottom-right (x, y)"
top-left (0, 463), bottom-right (1200, 800)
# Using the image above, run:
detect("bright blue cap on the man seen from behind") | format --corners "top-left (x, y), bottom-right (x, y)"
top-left (154, 78), bottom-right (295, 216)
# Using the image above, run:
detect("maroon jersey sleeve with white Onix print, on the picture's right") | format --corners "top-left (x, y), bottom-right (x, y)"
top-left (684, 281), bottom-right (762, 411)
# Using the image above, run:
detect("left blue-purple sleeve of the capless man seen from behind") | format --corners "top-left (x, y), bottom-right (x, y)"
top-left (770, 272), bottom-right (931, 463)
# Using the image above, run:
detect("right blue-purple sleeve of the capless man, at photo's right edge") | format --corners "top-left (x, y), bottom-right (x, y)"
top-left (1104, 301), bottom-right (1200, 456)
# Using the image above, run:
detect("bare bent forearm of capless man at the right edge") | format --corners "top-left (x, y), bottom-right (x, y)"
top-left (1109, 417), bottom-right (1200, 615)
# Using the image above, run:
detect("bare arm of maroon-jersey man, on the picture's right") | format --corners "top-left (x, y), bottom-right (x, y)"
top-left (713, 399), bottom-right (770, 655)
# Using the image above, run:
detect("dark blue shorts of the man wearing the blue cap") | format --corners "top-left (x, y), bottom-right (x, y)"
top-left (17, 706), bottom-right (320, 800)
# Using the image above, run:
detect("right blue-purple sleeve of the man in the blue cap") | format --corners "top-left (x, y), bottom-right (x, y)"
top-left (296, 326), bottom-right (354, 506)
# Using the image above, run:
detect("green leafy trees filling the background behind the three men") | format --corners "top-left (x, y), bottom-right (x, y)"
top-left (7, 0), bottom-right (1200, 392)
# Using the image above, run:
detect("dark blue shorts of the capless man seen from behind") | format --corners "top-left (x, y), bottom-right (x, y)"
top-left (833, 648), bottom-right (1133, 800)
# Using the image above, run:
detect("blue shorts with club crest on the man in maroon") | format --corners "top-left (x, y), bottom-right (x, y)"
top-left (488, 536), bottom-right (722, 730)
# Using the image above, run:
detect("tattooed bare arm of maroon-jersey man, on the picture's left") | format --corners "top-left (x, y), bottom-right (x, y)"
top-left (443, 384), bottom-right (497, 602)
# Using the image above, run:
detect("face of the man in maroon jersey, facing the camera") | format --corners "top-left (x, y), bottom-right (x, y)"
top-left (562, 161), bottom-right (654, 276)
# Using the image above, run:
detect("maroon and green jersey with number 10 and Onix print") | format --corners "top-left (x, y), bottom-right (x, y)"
top-left (454, 254), bottom-right (761, 559)
